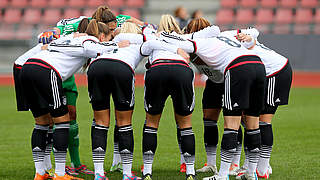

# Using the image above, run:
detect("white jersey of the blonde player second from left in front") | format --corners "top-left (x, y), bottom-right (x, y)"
top-left (92, 33), bottom-right (143, 70)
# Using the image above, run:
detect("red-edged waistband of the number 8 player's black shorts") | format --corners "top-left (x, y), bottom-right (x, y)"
top-left (225, 55), bottom-right (263, 72)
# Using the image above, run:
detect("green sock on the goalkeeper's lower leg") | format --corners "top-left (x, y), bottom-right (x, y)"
top-left (69, 120), bottom-right (81, 168)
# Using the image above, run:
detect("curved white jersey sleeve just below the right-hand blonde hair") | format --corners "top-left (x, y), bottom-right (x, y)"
top-left (140, 39), bottom-right (178, 56)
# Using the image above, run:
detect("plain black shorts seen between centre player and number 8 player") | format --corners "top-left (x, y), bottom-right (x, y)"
top-left (202, 79), bottom-right (224, 109)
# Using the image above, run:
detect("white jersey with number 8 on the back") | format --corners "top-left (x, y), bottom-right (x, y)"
top-left (162, 32), bottom-right (256, 77)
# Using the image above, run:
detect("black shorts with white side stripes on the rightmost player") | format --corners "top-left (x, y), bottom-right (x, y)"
top-left (261, 61), bottom-right (292, 114)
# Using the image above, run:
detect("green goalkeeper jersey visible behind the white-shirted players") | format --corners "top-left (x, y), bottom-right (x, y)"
top-left (56, 14), bottom-right (131, 35)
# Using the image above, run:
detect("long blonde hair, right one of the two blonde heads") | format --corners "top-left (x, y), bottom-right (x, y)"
top-left (158, 14), bottom-right (182, 34)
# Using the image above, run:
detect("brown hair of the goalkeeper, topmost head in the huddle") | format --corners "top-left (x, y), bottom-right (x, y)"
top-left (92, 6), bottom-right (117, 24)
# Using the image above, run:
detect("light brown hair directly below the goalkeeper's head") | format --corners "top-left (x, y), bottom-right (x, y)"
top-left (85, 19), bottom-right (111, 38)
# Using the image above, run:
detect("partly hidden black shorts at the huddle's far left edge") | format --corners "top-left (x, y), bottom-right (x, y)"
top-left (13, 64), bottom-right (30, 111)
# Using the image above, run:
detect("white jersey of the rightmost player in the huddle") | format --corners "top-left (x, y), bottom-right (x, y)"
top-left (221, 28), bottom-right (288, 76)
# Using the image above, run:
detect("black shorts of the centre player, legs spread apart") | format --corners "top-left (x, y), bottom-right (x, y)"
top-left (144, 61), bottom-right (194, 116)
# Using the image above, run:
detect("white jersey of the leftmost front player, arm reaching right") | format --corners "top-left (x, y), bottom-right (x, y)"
top-left (30, 34), bottom-right (118, 81)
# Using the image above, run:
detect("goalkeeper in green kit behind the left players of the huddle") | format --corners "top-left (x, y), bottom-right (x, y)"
top-left (39, 6), bottom-right (135, 175)
